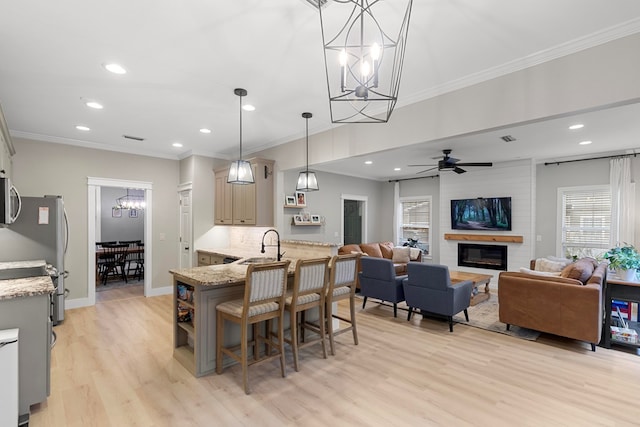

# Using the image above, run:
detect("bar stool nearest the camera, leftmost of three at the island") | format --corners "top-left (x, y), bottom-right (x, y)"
top-left (216, 261), bottom-right (290, 394)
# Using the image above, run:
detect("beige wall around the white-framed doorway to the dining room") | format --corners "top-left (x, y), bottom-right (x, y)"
top-left (13, 138), bottom-right (179, 300)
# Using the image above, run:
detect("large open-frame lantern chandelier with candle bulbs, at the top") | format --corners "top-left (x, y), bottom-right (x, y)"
top-left (318, 0), bottom-right (413, 123)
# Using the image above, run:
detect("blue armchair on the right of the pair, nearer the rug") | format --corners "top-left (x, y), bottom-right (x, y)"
top-left (403, 262), bottom-right (473, 332)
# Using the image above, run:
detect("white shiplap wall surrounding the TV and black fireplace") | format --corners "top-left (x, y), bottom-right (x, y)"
top-left (434, 160), bottom-right (536, 284)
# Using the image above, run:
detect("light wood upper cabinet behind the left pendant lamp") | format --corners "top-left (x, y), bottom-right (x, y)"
top-left (214, 159), bottom-right (274, 227)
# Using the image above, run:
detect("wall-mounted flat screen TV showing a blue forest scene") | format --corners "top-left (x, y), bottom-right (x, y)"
top-left (451, 197), bottom-right (511, 231)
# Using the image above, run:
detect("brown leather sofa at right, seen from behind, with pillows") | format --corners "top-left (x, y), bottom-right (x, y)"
top-left (498, 258), bottom-right (607, 351)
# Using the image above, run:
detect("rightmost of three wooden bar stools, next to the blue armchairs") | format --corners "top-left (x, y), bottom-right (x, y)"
top-left (326, 254), bottom-right (360, 356)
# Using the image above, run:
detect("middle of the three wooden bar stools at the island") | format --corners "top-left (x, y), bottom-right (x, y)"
top-left (285, 257), bottom-right (331, 372)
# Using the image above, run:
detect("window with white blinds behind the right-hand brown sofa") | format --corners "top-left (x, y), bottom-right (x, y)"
top-left (558, 185), bottom-right (611, 257)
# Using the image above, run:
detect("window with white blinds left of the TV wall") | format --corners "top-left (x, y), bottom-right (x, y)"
top-left (398, 196), bottom-right (431, 254)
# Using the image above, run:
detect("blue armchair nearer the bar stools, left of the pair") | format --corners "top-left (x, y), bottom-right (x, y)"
top-left (358, 257), bottom-right (407, 317)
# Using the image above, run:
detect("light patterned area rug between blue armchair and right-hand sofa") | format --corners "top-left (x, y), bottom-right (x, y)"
top-left (453, 295), bottom-right (540, 341)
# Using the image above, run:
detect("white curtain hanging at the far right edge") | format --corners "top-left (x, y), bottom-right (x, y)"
top-left (609, 157), bottom-right (635, 247)
